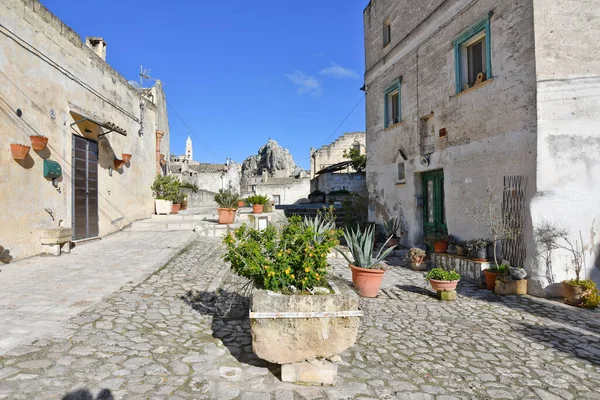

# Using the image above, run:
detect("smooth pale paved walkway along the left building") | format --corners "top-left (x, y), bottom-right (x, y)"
top-left (0, 232), bottom-right (196, 355)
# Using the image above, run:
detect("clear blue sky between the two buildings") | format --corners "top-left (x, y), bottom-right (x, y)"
top-left (42, 0), bottom-right (368, 168)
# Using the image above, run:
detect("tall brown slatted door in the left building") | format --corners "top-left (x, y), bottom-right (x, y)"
top-left (72, 136), bottom-right (99, 240)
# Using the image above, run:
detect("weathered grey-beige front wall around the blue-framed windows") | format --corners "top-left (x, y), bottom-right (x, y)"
top-left (365, 0), bottom-right (536, 250)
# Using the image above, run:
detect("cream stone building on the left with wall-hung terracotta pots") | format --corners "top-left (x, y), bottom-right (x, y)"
top-left (0, 0), bottom-right (169, 262)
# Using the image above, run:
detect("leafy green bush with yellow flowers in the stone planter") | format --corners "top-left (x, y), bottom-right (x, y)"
top-left (223, 216), bottom-right (339, 293)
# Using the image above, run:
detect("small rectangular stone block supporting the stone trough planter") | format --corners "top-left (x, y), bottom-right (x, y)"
top-left (281, 360), bottom-right (337, 386)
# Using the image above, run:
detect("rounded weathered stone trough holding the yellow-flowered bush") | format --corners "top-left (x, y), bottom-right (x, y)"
top-left (250, 279), bottom-right (362, 364)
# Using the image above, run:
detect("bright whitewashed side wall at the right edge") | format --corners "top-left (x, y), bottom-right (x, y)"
top-left (531, 0), bottom-right (600, 294)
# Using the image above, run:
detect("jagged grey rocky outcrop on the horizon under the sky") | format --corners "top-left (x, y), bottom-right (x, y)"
top-left (242, 139), bottom-right (302, 178)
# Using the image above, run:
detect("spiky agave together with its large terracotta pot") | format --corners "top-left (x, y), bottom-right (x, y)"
top-left (337, 226), bottom-right (394, 297)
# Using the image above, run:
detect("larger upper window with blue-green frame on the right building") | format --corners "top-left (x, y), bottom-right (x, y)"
top-left (452, 13), bottom-right (492, 93)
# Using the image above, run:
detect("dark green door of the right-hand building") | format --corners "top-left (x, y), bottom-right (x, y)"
top-left (423, 169), bottom-right (448, 236)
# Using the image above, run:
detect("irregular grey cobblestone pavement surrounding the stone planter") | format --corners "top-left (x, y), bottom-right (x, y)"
top-left (0, 238), bottom-right (600, 400)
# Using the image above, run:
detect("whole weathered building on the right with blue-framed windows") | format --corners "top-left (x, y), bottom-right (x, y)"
top-left (364, 0), bottom-right (600, 295)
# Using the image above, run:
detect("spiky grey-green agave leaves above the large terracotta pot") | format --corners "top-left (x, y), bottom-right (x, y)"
top-left (336, 226), bottom-right (396, 269)
